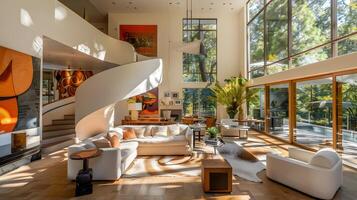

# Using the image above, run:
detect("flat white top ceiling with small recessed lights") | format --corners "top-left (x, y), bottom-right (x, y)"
top-left (90, 0), bottom-right (245, 14)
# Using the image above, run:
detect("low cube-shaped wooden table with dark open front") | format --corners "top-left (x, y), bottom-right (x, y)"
top-left (201, 159), bottom-right (232, 193)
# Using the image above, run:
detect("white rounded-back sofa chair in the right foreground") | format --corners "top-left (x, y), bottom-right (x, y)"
top-left (266, 148), bottom-right (342, 199)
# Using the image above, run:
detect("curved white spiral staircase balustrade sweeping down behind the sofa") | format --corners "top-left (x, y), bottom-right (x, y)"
top-left (75, 59), bottom-right (162, 140)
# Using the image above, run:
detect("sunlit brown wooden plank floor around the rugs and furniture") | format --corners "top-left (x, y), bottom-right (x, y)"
top-left (0, 132), bottom-right (357, 200)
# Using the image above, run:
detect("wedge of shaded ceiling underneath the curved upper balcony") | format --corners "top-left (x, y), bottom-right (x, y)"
top-left (43, 37), bottom-right (117, 71)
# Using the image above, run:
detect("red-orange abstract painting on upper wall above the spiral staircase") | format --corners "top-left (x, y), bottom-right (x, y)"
top-left (119, 25), bottom-right (157, 57)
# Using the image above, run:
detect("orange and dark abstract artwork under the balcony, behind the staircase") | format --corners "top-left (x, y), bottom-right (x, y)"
top-left (54, 70), bottom-right (93, 99)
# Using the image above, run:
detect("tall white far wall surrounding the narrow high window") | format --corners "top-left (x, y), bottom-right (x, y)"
top-left (108, 9), bottom-right (244, 121)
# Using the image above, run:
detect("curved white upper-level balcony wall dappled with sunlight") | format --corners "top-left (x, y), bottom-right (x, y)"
top-left (0, 0), bottom-right (136, 65)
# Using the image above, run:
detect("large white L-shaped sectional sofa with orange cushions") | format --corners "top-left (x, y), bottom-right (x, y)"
top-left (67, 124), bottom-right (193, 180)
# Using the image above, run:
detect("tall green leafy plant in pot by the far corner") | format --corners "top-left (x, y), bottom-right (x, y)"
top-left (211, 75), bottom-right (254, 119)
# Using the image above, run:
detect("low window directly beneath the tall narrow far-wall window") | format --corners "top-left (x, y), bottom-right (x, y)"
top-left (183, 88), bottom-right (217, 117)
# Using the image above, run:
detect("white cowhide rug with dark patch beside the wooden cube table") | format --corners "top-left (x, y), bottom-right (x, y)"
top-left (217, 142), bottom-right (265, 182)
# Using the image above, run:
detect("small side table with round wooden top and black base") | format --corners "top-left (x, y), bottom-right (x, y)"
top-left (70, 149), bottom-right (102, 196)
